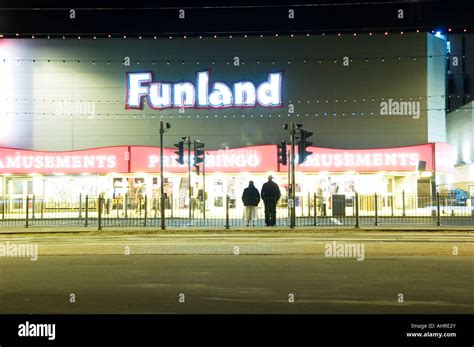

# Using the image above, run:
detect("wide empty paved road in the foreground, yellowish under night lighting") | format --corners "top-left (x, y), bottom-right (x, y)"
top-left (0, 232), bottom-right (474, 313)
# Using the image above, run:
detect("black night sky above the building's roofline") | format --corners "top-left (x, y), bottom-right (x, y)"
top-left (0, 0), bottom-right (474, 37)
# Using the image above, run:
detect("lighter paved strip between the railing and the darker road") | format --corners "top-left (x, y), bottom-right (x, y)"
top-left (0, 228), bottom-right (474, 257)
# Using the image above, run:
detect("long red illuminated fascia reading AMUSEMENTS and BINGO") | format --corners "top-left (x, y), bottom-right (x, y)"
top-left (0, 143), bottom-right (453, 174)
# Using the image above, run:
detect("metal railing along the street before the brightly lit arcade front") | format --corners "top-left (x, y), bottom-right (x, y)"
top-left (0, 192), bottom-right (474, 230)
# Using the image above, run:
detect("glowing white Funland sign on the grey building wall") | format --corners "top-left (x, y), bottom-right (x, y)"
top-left (125, 70), bottom-right (283, 110)
